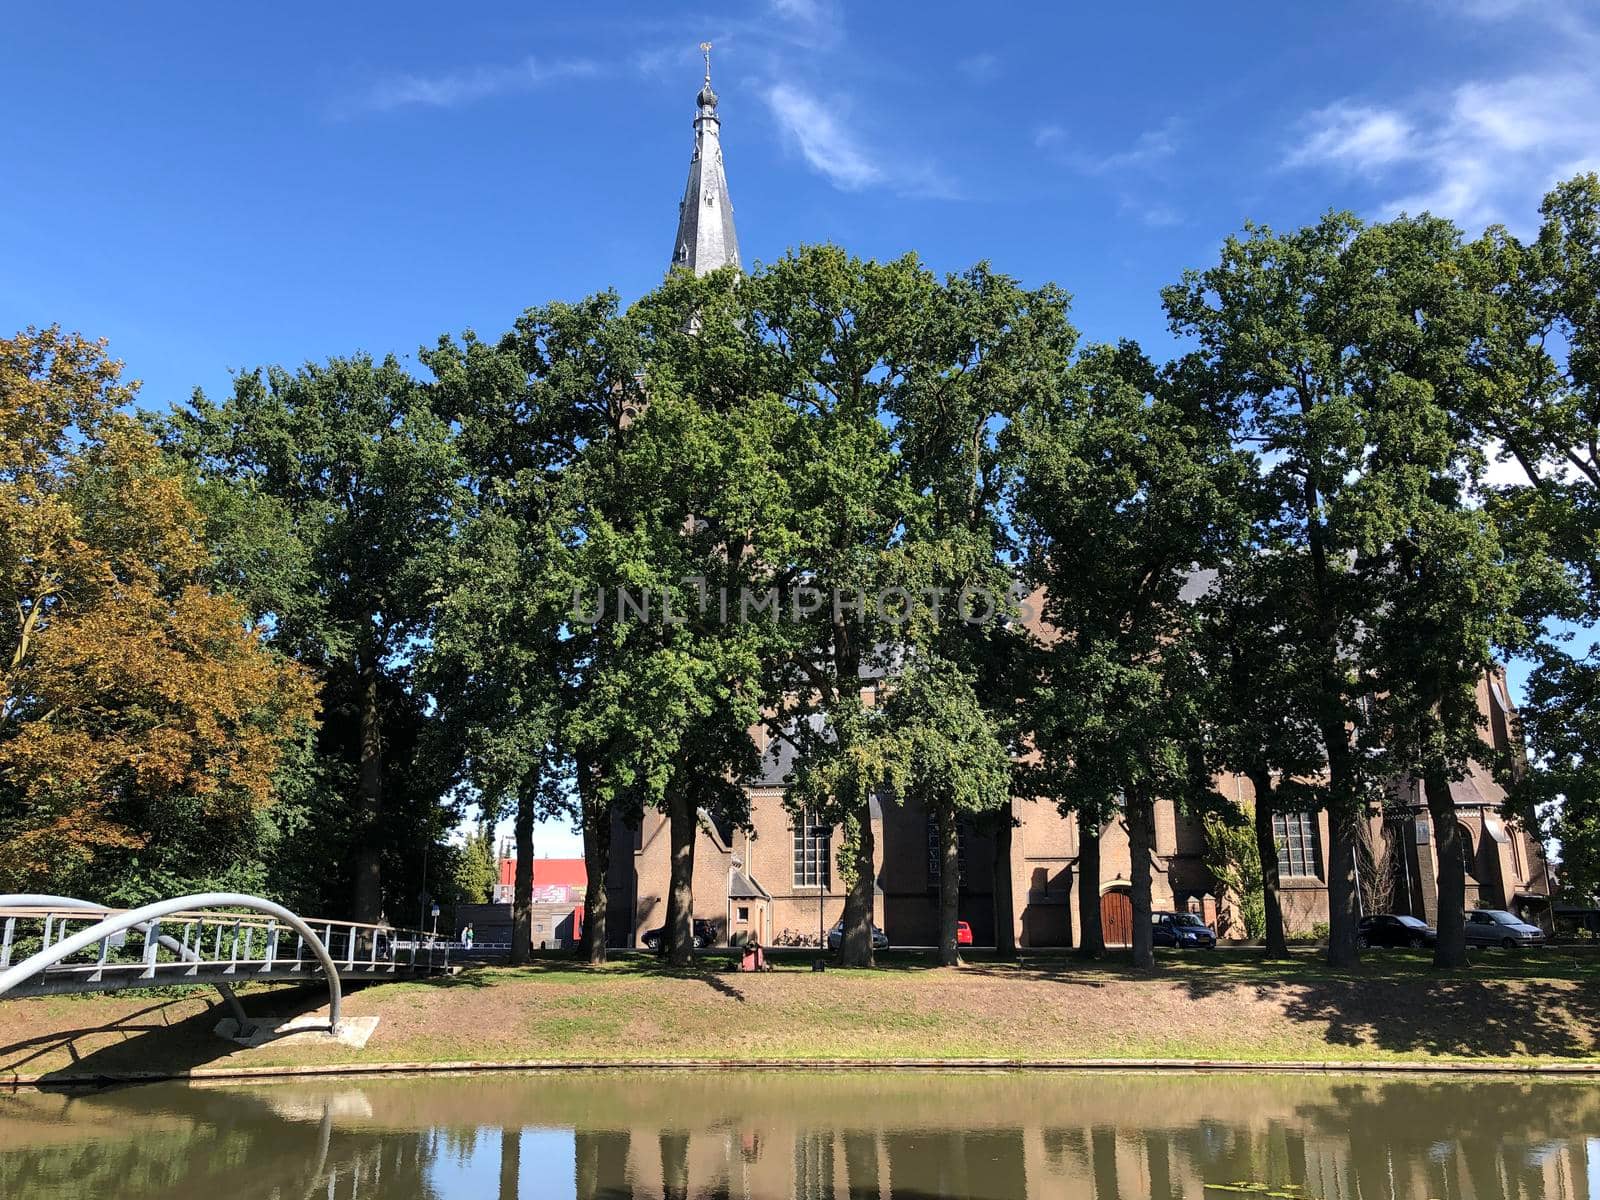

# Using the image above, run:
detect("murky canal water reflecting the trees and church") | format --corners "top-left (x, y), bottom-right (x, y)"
top-left (0, 1072), bottom-right (1600, 1200)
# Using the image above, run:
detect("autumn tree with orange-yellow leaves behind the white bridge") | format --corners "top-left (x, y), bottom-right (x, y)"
top-left (0, 328), bottom-right (315, 899)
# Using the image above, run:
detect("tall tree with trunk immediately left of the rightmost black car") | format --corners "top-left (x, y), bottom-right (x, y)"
top-left (1163, 214), bottom-right (1379, 966)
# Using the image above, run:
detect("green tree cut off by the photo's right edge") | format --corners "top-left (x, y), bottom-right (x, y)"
top-left (1467, 173), bottom-right (1600, 898)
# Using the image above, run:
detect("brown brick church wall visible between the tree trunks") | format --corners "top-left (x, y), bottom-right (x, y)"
top-left (595, 668), bottom-right (1547, 947)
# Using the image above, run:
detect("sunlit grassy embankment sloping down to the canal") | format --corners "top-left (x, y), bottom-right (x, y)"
top-left (0, 950), bottom-right (1600, 1080)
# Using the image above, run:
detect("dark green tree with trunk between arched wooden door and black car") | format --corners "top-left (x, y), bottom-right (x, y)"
top-left (1014, 344), bottom-right (1250, 966)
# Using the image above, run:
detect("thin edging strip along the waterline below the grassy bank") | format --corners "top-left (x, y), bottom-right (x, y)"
top-left (0, 1058), bottom-right (1600, 1090)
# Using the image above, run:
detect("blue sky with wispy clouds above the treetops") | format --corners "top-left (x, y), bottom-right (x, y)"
top-left (0, 0), bottom-right (1600, 857)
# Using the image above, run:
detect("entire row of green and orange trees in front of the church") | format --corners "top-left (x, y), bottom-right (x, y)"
top-left (0, 167), bottom-right (1600, 966)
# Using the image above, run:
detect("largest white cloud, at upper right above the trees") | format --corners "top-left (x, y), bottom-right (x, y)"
top-left (1285, 67), bottom-right (1600, 227)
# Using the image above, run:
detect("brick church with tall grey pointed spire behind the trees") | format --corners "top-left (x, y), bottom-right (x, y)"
top-left (606, 61), bottom-right (1550, 947)
